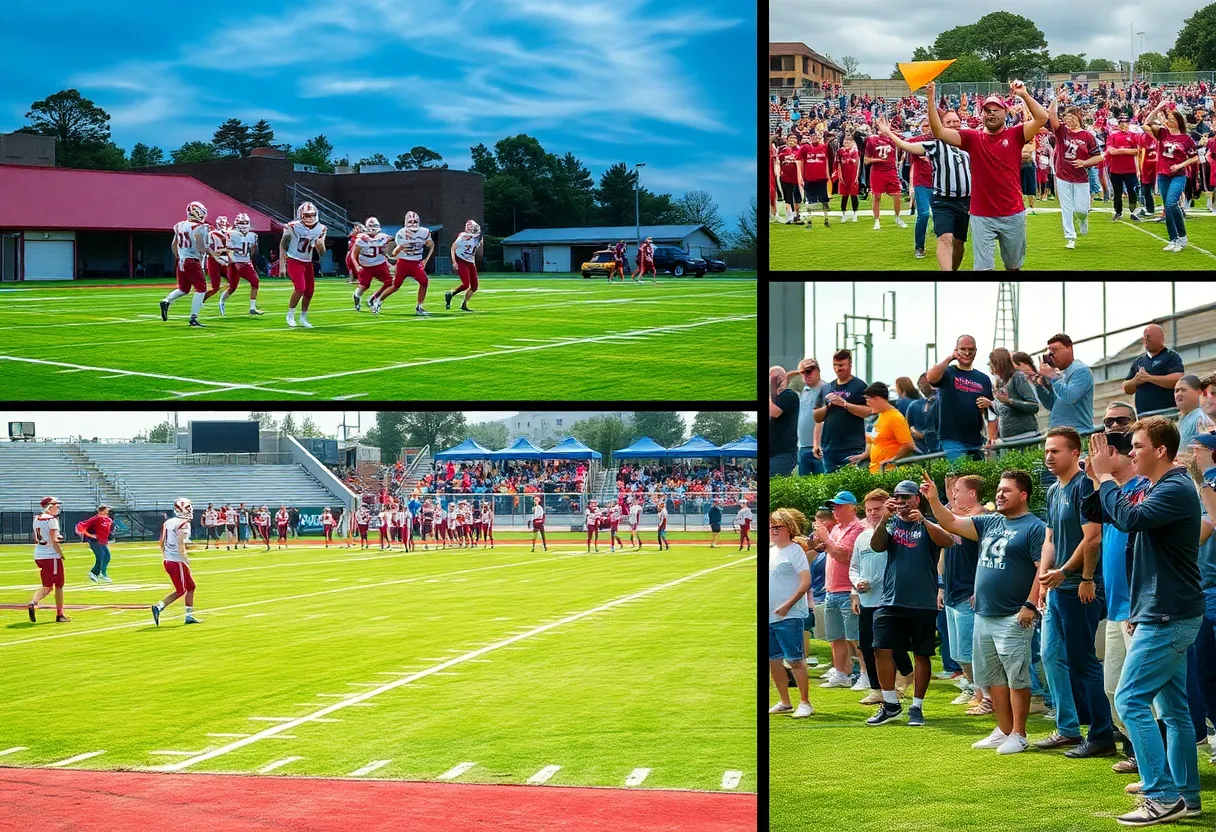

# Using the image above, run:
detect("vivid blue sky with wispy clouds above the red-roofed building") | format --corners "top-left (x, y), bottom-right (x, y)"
top-left (0, 0), bottom-right (756, 218)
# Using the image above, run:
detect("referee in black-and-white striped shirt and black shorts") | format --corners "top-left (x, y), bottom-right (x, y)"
top-left (878, 110), bottom-right (972, 271)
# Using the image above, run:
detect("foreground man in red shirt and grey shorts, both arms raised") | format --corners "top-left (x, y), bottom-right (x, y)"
top-left (925, 80), bottom-right (1047, 271)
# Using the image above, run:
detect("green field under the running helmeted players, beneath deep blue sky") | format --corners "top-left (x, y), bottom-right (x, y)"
top-left (0, 272), bottom-right (756, 401)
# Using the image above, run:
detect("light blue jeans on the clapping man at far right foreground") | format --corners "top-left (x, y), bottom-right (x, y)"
top-left (1115, 615), bottom-right (1201, 805)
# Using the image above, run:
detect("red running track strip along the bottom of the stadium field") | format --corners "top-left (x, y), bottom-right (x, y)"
top-left (0, 769), bottom-right (759, 832)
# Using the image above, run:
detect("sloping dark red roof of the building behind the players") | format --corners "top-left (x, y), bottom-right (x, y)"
top-left (0, 164), bottom-right (277, 234)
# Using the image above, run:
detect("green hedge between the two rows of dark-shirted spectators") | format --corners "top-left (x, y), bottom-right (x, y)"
top-left (769, 448), bottom-right (1047, 518)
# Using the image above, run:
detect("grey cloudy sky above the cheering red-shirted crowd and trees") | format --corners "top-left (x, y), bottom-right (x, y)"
top-left (769, 0), bottom-right (1206, 78)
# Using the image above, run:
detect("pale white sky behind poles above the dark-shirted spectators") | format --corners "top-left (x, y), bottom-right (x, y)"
top-left (806, 279), bottom-right (1216, 384)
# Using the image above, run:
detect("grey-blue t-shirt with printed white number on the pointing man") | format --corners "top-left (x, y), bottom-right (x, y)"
top-left (970, 513), bottom-right (1047, 617)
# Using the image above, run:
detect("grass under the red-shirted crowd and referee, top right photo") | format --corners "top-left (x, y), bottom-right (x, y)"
top-left (769, 197), bottom-right (1216, 271)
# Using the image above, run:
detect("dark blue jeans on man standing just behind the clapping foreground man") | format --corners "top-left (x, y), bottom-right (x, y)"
top-left (1043, 590), bottom-right (1114, 744)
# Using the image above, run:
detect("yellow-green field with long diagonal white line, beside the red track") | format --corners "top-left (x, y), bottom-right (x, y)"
top-left (0, 532), bottom-right (758, 792)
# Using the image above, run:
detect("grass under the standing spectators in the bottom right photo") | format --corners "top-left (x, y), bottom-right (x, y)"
top-left (769, 641), bottom-right (1216, 832)
